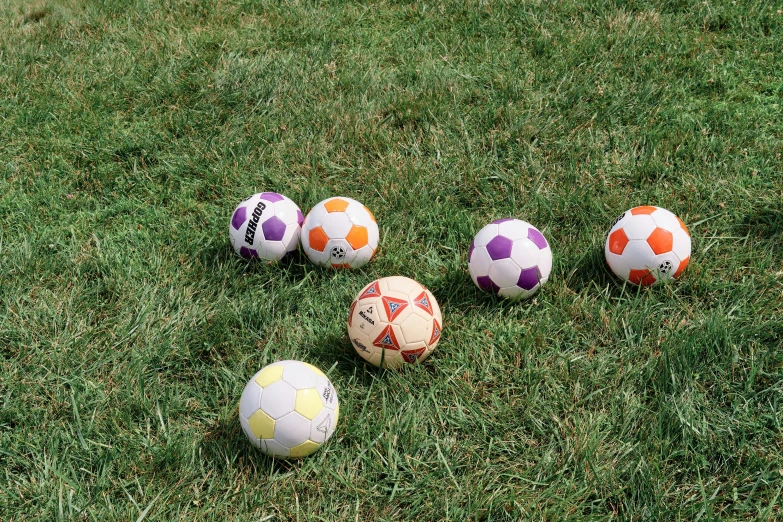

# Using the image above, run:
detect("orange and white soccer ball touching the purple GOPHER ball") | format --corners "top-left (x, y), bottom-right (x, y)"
top-left (302, 197), bottom-right (378, 268)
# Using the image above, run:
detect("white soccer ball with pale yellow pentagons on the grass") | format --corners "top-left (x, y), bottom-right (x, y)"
top-left (239, 361), bottom-right (340, 458)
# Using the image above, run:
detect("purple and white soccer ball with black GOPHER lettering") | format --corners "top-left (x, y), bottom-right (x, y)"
top-left (228, 192), bottom-right (304, 261)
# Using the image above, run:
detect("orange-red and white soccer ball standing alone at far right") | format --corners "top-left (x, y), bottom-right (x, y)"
top-left (604, 206), bottom-right (691, 286)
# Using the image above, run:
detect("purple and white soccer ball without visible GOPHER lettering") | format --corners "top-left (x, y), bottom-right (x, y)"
top-left (468, 218), bottom-right (552, 299)
